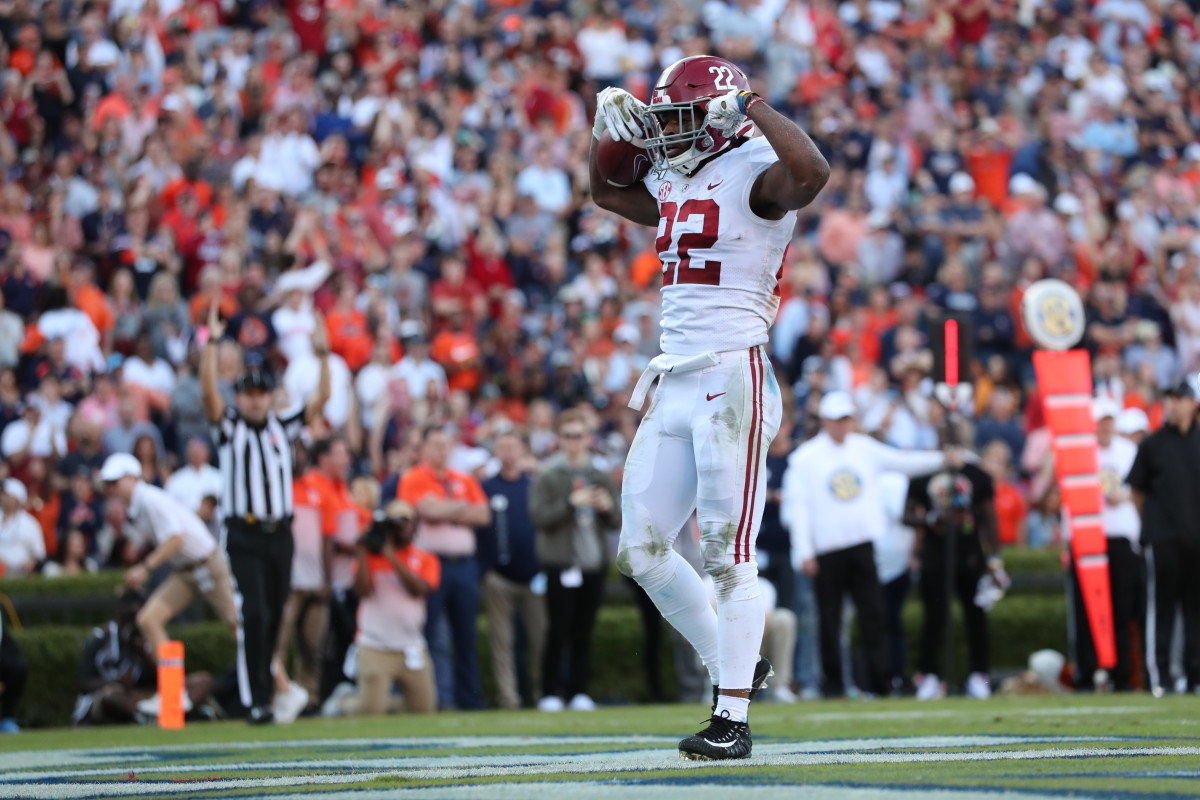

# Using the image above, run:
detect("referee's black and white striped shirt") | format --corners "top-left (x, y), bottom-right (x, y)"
top-left (214, 407), bottom-right (304, 522)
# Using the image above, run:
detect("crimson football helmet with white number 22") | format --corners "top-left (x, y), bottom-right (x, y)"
top-left (646, 55), bottom-right (750, 175)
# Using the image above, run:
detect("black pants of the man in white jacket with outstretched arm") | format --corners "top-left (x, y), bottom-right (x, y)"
top-left (814, 542), bottom-right (888, 697)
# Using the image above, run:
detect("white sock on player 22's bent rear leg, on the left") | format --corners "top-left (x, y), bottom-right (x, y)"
top-left (637, 549), bottom-right (720, 686)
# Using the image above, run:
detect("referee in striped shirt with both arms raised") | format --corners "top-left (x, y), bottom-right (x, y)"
top-left (200, 302), bottom-right (329, 724)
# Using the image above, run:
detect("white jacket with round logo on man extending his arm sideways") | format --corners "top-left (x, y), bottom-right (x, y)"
top-left (779, 433), bottom-right (946, 567)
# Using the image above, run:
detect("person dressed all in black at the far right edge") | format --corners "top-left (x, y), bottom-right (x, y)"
top-left (1126, 375), bottom-right (1200, 697)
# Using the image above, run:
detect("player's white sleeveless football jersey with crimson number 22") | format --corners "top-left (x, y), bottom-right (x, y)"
top-left (644, 137), bottom-right (797, 355)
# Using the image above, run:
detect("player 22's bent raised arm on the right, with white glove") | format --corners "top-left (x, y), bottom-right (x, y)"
top-left (708, 91), bottom-right (829, 219)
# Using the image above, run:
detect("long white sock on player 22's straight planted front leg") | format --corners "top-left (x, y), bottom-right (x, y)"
top-left (716, 563), bottom-right (766, 702)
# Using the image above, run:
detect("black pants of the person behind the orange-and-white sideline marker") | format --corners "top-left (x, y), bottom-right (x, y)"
top-left (1070, 536), bottom-right (1142, 692)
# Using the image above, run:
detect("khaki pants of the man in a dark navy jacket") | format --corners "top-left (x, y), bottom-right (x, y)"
top-left (484, 570), bottom-right (546, 709)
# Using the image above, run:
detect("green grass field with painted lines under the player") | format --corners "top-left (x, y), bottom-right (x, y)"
top-left (0, 694), bottom-right (1200, 798)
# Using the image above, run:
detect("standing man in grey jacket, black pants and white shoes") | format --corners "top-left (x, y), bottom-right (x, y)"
top-left (529, 409), bottom-right (620, 711)
